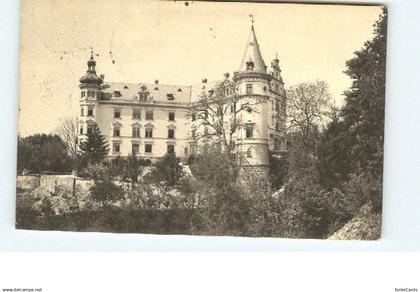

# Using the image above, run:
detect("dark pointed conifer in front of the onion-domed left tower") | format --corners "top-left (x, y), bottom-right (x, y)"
top-left (80, 124), bottom-right (109, 163)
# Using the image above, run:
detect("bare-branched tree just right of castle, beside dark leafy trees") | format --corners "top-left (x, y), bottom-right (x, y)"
top-left (287, 81), bottom-right (333, 167)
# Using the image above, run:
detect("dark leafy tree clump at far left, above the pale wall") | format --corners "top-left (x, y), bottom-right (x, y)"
top-left (17, 134), bottom-right (71, 173)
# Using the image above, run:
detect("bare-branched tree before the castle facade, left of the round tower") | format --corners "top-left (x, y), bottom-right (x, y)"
top-left (191, 73), bottom-right (262, 154)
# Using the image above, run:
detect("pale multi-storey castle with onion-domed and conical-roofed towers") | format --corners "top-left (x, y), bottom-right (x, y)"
top-left (79, 25), bottom-right (286, 170)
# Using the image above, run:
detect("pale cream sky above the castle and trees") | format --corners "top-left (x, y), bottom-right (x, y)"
top-left (19, 0), bottom-right (381, 136)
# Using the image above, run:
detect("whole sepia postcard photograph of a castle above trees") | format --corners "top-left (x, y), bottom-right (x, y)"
top-left (13, 0), bottom-right (387, 240)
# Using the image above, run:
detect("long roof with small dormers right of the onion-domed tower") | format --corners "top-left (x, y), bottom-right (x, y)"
top-left (103, 82), bottom-right (191, 103)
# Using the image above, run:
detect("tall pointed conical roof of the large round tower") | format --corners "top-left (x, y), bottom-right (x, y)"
top-left (239, 25), bottom-right (267, 73)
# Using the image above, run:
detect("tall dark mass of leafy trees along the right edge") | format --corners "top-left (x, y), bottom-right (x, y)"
top-left (318, 10), bottom-right (387, 203)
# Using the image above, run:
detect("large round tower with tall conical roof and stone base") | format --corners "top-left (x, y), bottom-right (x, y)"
top-left (234, 25), bottom-right (271, 175)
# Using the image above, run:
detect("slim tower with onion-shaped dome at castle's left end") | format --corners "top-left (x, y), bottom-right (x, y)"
top-left (79, 51), bottom-right (103, 139)
